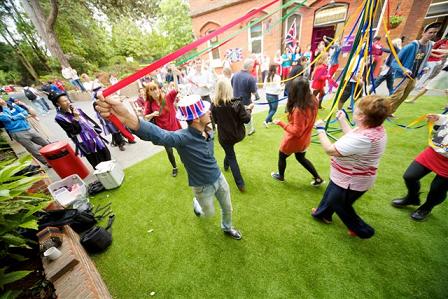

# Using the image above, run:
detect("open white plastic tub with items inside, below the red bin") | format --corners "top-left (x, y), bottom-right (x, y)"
top-left (48, 174), bottom-right (88, 208)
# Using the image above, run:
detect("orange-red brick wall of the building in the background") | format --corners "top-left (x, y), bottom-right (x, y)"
top-left (190, 0), bottom-right (431, 71)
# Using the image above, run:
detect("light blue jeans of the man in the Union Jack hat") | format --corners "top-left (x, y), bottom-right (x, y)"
top-left (191, 173), bottom-right (232, 231)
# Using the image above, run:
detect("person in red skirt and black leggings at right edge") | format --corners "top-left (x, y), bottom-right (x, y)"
top-left (392, 114), bottom-right (448, 221)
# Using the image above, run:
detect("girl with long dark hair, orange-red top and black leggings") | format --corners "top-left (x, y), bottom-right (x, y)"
top-left (271, 77), bottom-right (324, 187)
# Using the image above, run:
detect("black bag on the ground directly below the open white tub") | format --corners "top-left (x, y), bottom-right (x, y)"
top-left (39, 209), bottom-right (97, 233)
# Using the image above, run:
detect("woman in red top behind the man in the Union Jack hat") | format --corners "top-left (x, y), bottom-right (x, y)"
top-left (143, 81), bottom-right (181, 177)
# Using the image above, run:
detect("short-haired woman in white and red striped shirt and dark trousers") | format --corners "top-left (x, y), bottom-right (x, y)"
top-left (311, 95), bottom-right (390, 239)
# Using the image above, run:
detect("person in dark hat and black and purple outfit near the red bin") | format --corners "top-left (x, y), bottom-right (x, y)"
top-left (48, 92), bottom-right (111, 169)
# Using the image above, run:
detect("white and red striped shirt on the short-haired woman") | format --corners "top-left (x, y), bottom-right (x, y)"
top-left (330, 126), bottom-right (387, 191)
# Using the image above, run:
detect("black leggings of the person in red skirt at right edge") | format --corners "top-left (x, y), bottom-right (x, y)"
top-left (403, 160), bottom-right (448, 211)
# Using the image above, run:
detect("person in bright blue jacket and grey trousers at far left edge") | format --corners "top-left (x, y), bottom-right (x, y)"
top-left (0, 98), bottom-right (48, 165)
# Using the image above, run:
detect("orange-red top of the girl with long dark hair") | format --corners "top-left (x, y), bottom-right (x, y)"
top-left (278, 96), bottom-right (319, 155)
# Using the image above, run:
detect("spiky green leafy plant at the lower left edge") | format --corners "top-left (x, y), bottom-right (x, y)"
top-left (0, 156), bottom-right (48, 288)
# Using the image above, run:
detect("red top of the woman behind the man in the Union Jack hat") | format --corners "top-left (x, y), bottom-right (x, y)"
top-left (144, 89), bottom-right (181, 131)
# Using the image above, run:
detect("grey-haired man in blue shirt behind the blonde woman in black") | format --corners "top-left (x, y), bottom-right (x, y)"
top-left (231, 58), bottom-right (257, 136)
